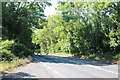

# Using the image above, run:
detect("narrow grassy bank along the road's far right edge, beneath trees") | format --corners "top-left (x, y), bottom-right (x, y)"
top-left (42, 53), bottom-right (120, 63)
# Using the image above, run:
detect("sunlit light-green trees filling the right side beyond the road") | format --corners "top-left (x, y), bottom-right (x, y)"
top-left (32, 2), bottom-right (120, 58)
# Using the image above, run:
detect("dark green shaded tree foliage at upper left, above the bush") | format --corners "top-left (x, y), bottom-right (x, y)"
top-left (2, 2), bottom-right (51, 48)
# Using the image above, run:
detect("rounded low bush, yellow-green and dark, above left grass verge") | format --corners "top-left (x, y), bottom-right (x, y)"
top-left (2, 40), bottom-right (32, 61)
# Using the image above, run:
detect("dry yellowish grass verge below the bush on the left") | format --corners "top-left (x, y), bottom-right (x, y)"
top-left (0, 58), bottom-right (31, 72)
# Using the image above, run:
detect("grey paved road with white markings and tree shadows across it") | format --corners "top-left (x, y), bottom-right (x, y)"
top-left (2, 55), bottom-right (118, 78)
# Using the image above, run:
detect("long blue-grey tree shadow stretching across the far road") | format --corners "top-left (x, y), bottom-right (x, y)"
top-left (34, 55), bottom-right (114, 66)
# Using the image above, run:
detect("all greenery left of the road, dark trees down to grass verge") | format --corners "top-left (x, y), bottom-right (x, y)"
top-left (0, 2), bottom-right (50, 72)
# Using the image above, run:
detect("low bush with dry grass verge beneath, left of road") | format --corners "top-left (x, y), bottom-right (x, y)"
top-left (0, 40), bottom-right (33, 72)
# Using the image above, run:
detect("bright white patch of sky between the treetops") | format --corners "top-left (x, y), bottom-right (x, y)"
top-left (44, 0), bottom-right (58, 16)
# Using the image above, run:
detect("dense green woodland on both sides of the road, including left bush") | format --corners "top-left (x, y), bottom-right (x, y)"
top-left (2, 2), bottom-right (120, 60)
